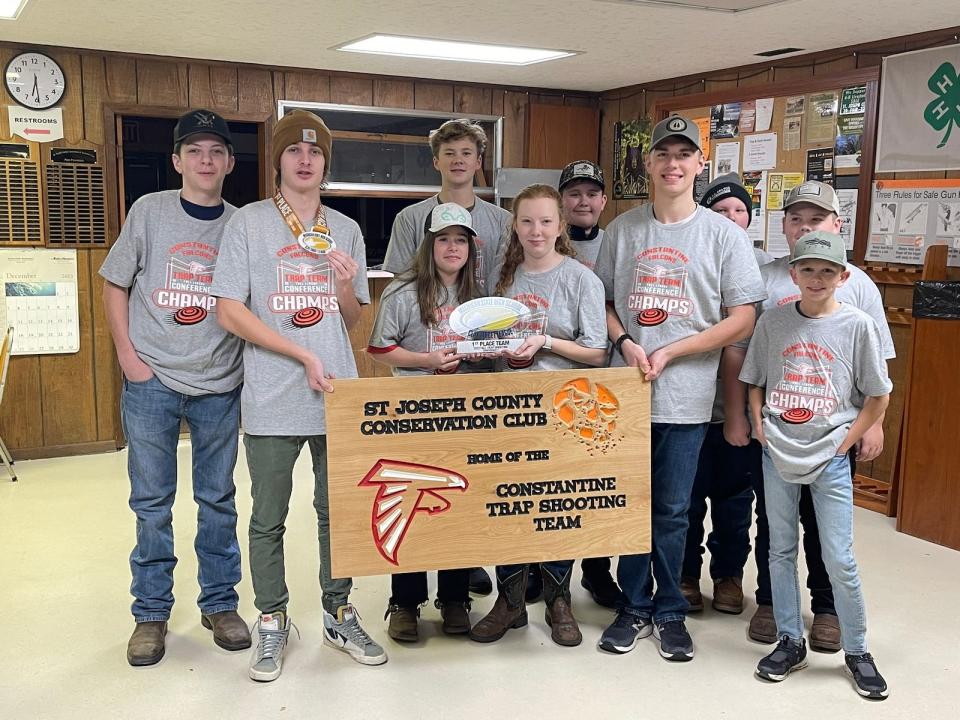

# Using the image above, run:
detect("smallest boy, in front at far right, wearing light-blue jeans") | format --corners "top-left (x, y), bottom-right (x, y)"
top-left (740, 230), bottom-right (892, 699)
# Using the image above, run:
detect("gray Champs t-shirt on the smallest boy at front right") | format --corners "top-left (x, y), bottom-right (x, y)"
top-left (740, 302), bottom-right (893, 483)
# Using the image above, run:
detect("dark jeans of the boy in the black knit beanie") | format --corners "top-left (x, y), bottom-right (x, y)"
top-left (682, 423), bottom-right (763, 580)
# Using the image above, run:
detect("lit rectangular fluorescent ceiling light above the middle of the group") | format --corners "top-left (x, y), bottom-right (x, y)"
top-left (334, 35), bottom-right (576, 65)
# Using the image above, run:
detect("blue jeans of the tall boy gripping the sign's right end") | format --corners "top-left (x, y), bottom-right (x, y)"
top-left (617, 423), bottom-right (707, 623)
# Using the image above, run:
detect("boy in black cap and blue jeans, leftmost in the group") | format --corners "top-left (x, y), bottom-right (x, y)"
top-left (100, 110), bottom-right (250, 666)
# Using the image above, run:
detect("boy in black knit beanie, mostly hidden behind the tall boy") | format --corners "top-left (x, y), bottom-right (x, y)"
top-left (680, 173), bottom-right (773, 615)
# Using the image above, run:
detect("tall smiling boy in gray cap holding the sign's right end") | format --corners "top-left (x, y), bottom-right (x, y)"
top-left (595, 115), bottom-right (765, 661)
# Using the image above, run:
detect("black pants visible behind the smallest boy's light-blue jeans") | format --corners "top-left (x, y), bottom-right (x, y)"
top-left (753, 456), bottom-right (837, 615)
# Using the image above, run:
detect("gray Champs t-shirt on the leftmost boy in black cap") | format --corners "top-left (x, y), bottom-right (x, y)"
top-left (100, 190), bottom-right (243, 395)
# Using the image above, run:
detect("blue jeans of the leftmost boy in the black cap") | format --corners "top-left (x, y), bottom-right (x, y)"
top-left (120, 377), bottom-right (240, 623)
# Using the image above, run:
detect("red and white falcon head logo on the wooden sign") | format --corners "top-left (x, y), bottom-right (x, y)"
top-left (359, 459), bottom-right (467, 565)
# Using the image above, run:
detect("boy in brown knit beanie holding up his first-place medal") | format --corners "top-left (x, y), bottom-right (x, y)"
top-left (212, 110), bottom-right (387, 682)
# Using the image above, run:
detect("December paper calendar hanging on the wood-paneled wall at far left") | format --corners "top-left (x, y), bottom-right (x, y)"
top-left (0, 248), bottom-right (80, 355)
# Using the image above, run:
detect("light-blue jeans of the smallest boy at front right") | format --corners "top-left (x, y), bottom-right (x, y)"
top-left (763, 450), bottom-right (867, 655)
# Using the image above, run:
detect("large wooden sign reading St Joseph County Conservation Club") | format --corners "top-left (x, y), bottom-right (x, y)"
top-left (325, 368), bottom-right (650, 577)
